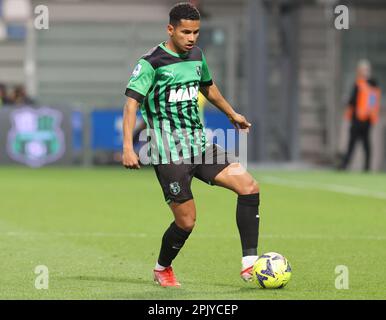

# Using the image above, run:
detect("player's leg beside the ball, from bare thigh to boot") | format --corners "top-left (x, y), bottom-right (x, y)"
top-left (214, 163), bottom-right (260, 280)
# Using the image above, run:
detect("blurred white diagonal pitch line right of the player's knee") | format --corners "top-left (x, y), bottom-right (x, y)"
top-left (260, 176), bottom-right (386, 200)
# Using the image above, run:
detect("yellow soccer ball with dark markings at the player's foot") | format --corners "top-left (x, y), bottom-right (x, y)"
top-left (252, 252), bottom-right (292, 289)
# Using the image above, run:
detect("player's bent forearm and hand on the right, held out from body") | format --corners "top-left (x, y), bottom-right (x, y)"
top-left (200, 83), bottom-right (251, 129)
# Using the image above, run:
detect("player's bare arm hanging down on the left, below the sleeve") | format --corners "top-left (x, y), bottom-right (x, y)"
top-left (122, 97), bottom-right (140, 169)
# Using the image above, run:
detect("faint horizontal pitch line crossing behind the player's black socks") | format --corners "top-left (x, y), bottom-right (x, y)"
top-left (0, 231), bottom-right (386, 241)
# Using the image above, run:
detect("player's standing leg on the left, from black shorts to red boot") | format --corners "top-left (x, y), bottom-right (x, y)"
top-left (154, 164), bottom-right (196, 287)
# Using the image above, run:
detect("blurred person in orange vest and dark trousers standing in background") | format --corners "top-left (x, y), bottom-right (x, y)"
top-left (339, 60), bottom-right (381, 171)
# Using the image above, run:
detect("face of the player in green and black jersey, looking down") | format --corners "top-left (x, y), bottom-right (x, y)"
top-left (168, 19), bottom-right (200, 52)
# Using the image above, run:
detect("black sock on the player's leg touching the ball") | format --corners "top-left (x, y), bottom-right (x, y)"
top-left (236, 193), bottom-right (260, 257)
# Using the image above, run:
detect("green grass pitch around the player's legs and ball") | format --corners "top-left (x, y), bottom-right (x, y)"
top-left (0, 167), bottom-right (386, 300)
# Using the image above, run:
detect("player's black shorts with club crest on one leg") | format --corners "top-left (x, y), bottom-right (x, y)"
top-left (153, 144), bottom-right (234, 203)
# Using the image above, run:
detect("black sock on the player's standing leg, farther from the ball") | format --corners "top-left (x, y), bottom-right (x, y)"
top-left (158, 222), bottom-right (191, 267)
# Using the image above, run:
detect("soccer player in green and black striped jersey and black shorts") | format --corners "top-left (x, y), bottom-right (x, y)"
top-left (122, 3), bottom-right (260, 287)
